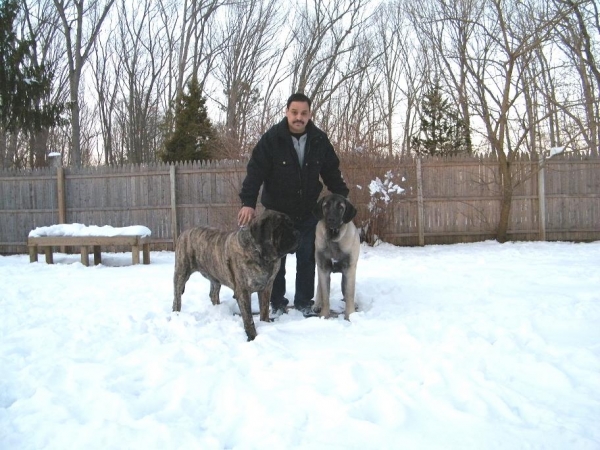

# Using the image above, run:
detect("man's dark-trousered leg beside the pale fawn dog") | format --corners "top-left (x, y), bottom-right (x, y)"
top-left (294, 216), bottom-right (317, 309)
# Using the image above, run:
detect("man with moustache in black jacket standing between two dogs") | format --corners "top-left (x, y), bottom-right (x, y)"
top-left (238, 93), bottom-right (348, 314)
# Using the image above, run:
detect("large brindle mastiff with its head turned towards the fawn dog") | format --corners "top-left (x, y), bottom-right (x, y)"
top-left (173, 210), bottom-right (298, 341)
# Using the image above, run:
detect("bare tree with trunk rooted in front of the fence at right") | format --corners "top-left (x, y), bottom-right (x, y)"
top-left (466, 0), bottom-right (560, 242)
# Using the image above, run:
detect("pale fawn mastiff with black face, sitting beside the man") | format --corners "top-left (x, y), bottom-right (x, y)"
top-left (313, 194), bottom-right (360, 320)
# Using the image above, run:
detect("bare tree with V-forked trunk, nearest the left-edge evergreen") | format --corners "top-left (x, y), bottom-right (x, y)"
top-left (54, 0), bottom-right (115, 167)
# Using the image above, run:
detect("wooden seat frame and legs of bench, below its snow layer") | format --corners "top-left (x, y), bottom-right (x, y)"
top-left (27, 236), bottom-right (150, 266)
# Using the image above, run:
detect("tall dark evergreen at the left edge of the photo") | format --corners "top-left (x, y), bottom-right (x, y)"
top-left (0, 0), bottom-right (64, 132)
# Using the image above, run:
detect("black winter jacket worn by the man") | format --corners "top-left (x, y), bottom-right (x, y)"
top-left (240, 118), bottom-right (348, 220)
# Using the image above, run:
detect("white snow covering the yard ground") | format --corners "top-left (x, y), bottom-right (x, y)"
top-left (0, 242), bottom-right (600, 450)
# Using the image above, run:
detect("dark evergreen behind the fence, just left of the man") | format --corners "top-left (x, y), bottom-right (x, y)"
top-left (159, 77), bottom-right (215, 162)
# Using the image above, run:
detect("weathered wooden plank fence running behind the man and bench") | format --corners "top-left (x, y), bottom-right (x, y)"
top-left (0, 156), bottom-right (600, 254)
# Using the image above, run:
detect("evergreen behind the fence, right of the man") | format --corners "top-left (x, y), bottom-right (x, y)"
top-left (412, 83), bottom-right (470, 156)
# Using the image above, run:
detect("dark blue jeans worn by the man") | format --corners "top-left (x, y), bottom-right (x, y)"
top-left (271, 215), bottom-right (318, 302)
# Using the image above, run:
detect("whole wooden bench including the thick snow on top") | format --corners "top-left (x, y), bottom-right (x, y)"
top-left (27, 223), bottom-right (151, 266)
